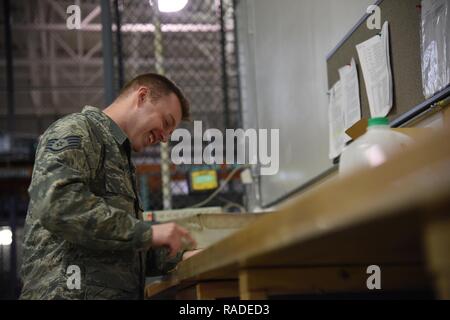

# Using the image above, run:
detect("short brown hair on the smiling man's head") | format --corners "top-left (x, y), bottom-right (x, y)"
top-left (119, 73), bottom-right (190, 121)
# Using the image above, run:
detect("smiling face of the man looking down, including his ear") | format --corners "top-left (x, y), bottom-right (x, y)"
top-left (128, 87), bottom-right (182, 152)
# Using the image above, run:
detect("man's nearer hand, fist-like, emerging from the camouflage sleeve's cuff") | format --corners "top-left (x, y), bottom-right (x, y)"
top-left (152, 223), bottom-right (197, 258)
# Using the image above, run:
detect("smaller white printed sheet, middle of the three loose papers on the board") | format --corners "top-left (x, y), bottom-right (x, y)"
top-left (339, 58), bottom-right (361, 130)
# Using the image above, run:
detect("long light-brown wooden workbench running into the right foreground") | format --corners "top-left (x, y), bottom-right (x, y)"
top-left (146, 125), bottom-right (450, 299)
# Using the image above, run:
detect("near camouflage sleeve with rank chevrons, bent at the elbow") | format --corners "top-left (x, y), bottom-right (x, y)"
top-left (29, 116), bottom-right (152, 251)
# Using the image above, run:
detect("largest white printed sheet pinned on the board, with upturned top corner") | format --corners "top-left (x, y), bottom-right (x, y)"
top-left (356, 22), bottom-right (393, 117)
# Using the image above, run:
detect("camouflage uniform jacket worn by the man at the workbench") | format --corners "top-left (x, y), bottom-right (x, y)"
top-left (21, 106), bottom-right (180, 299)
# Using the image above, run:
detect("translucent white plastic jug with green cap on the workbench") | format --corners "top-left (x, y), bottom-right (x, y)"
top-left (339, 118), bottom-right (413, 176)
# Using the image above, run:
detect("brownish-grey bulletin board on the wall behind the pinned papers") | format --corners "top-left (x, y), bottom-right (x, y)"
top-left (327, 0), bottom-right (425, 122)
